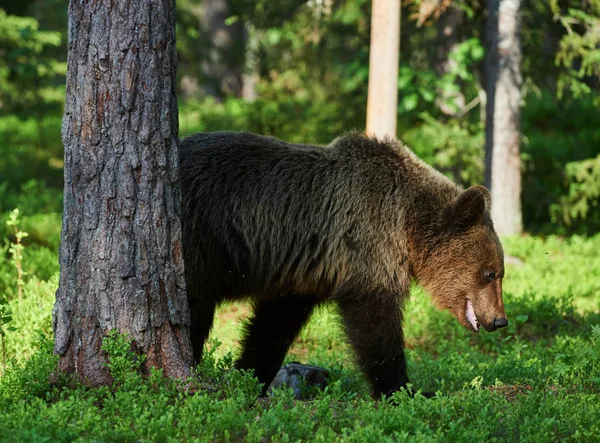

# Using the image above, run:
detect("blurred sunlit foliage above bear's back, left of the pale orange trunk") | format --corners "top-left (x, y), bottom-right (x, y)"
top-left (180, 0), bottom-right (370, 139)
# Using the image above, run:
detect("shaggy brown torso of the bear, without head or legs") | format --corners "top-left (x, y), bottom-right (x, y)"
top-left (181, 132), bottom-right (458, 300)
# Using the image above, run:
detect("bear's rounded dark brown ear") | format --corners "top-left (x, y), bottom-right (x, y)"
top-left (444, 186), bottom-right (492, 228)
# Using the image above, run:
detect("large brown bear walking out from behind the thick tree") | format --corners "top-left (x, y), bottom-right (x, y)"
top-left (180, 132), bottom-right (508, 396)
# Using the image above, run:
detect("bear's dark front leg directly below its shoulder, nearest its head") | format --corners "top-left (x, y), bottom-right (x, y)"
top-left (338, 293), bottom-right (408, 398)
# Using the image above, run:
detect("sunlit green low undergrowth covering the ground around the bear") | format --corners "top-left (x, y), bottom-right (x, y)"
top-left (0, 205), bottom-right (600, 442)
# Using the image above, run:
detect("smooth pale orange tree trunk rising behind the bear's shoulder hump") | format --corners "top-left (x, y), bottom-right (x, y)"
top-left (367, 0), bottom-right (400, 138)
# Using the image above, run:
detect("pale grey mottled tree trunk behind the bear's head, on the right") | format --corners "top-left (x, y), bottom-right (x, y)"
top-left (485, 0), bottom-right (523, 235)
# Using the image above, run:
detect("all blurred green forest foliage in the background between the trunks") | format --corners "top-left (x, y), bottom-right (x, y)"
top-left (0, 0), bottom-right (600, 236)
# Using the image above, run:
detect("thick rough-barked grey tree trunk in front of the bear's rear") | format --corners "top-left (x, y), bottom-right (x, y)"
top-left (53, 0), bottom-right (192, 385)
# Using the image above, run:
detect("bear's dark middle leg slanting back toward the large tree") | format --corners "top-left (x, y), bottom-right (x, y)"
top-left (236, 295), bottom-right (317, 393)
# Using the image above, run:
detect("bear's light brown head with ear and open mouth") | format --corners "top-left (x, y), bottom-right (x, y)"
top-left (418, 186), bottom-right (508, 332)
